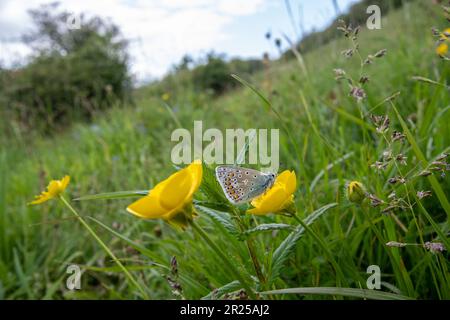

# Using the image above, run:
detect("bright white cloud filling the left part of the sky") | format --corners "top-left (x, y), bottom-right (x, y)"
top-left (0, 0), bottom-right (267, 80)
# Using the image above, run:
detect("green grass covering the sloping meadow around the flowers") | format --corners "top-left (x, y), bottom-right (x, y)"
top-left (0, 1), bottom-right (450, 299)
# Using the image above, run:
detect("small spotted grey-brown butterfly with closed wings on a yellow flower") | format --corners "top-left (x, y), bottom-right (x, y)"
top-left (216, 166), bottom-right (276, 204)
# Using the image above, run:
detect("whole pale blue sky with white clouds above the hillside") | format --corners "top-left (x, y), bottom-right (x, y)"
top-left (0, 0), bottom-right (357, 82)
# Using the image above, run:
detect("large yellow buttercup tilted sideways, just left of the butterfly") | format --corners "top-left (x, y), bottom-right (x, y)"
top-left (127, 160), bottom-right (203, 228)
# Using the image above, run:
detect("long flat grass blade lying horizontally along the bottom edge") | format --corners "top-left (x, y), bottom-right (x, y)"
top-left (260, 287), bottom-right (414, 300)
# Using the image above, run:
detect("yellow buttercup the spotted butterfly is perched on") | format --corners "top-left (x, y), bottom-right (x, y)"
top-left (247, 170), bottom-right (297, 215)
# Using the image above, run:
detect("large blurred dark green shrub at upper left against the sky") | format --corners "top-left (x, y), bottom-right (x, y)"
top-left (0, 4), bottom-right (131, 131)
